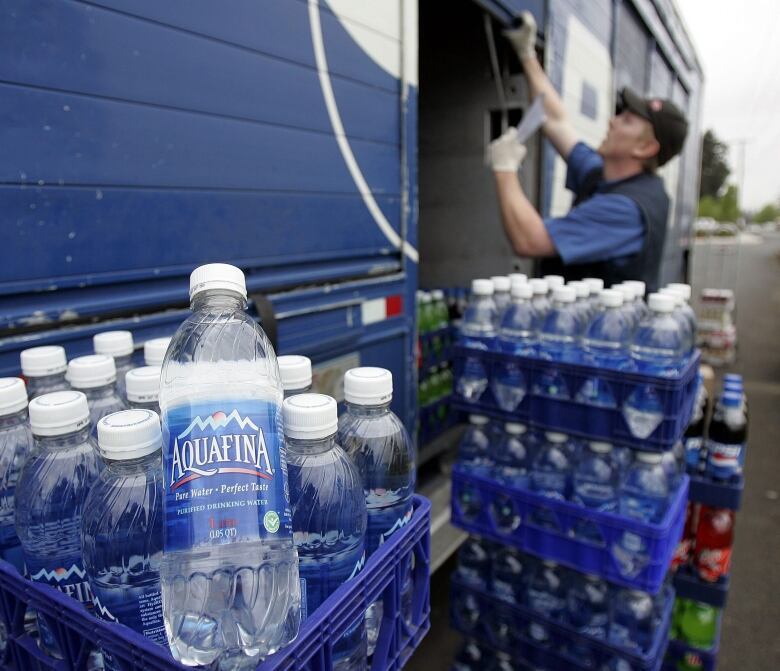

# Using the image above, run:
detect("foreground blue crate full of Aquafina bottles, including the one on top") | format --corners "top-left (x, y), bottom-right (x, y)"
top-left (0, 264), bottom-right (430, 671)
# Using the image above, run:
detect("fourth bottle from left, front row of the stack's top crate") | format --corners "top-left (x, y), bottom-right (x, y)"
top-left (577, 289), bottom-right (632, 408)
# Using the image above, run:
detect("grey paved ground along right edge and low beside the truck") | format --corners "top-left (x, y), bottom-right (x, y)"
top-left (406, 235), bottom-right (780, 671)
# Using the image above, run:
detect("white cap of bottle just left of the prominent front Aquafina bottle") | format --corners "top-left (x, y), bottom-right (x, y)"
top-left (98, 410), bottom-right (162, 461)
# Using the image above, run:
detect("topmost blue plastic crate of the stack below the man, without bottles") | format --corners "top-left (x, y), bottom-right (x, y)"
top-left (453, 345), bottom-right (700, 451)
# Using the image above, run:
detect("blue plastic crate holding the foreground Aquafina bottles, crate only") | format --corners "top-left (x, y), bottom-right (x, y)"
top-left (0, 496), bottom-right (431, 671)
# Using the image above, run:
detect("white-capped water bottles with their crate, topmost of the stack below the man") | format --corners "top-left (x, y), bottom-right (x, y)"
top-left (455, 276), bottom-right (699, 449)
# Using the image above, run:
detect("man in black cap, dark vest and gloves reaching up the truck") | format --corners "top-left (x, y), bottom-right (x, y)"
top-left (490, 12), bottom-right (688, 291)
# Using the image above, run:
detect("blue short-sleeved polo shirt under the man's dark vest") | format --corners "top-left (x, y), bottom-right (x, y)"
top-left (544, 142), bottom-right (645, 264)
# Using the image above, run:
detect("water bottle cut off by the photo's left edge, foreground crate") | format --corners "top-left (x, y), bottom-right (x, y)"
top-left (0, 377), bottom-right (33, 576)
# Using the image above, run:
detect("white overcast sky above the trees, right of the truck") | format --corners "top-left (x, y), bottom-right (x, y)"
top-left (677, 0), bottom-right (780, 209)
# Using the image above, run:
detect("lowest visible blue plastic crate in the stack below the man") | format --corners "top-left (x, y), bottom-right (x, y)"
top-left (450, 576), bottom-right (674, 671)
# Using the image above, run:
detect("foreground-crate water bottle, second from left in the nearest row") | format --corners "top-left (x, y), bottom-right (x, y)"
top-left (16, 392), bottom-right (100, 659)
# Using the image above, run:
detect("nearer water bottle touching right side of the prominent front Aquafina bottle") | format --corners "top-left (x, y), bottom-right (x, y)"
top-left (280, 394), bottom-right (367, 671)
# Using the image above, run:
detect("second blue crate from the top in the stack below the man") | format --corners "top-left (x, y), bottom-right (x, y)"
top-left (452, 464), bottom-right (688, 593)
